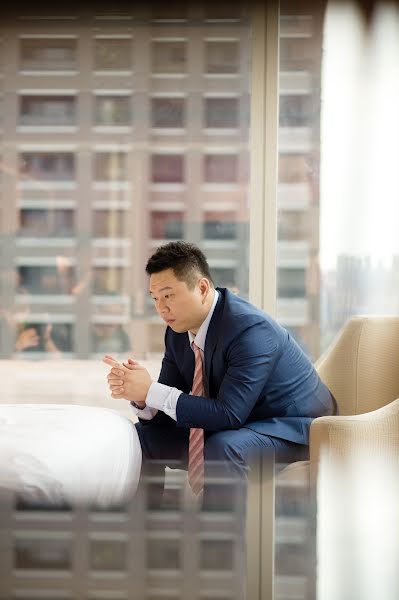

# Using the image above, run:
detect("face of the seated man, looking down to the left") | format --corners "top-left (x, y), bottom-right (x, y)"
top-left (150, 269), bottom-right (210, 334)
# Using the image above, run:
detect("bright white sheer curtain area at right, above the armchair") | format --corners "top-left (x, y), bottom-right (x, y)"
top-left (320, 2), bottom-right (399, 338)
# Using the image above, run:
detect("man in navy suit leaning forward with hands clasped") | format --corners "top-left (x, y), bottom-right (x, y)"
top-left (104, 242), bottom-right (336, 506)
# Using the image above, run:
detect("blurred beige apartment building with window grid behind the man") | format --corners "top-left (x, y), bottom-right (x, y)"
top-left (0, 2), bottom-right (319, 358)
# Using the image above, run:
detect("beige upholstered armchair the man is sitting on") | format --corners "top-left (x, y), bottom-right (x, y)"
top-left (279, 316), bottom-right (399, 482)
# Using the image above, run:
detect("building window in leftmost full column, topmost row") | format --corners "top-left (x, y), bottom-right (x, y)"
top-left (20, 38), bottom-right (77, 71)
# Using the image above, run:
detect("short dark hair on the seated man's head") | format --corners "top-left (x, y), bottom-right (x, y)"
top-left (145, 241), bottom-right (214, 289)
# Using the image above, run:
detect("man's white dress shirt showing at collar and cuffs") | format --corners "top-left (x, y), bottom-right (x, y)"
top-left (130, 290), bottom-right (219, 421)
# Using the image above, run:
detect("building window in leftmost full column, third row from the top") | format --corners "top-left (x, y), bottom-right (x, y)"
top-left (20, 152), bottom-right (75, 181)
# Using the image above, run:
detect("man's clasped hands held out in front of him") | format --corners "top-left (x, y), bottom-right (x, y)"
top-left (103, 354), bottom-right (152, 408)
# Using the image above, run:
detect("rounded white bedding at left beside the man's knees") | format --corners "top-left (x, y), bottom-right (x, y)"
top-left (0, 404), bottom-right (141, 508)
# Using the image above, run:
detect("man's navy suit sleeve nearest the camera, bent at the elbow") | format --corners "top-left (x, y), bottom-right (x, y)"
top-left (176, 322), bottom-right (281, 431)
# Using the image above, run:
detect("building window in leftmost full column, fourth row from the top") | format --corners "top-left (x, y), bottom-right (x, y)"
top-left (19, 208), bottom-right (74, 237)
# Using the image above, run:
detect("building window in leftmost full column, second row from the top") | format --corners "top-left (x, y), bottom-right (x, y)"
top-left (19, 95), bottom-right (76, 126)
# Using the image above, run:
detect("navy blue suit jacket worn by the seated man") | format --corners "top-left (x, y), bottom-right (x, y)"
top-left (142, 288), bottom-right (336, 444)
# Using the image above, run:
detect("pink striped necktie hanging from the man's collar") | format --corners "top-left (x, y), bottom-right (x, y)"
top-left (188, 342), bottom-right (205, 495)
